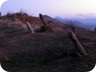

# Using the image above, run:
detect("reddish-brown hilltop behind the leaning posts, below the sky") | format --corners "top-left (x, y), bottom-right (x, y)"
top-left (0, 12), bottom-right (64, 31)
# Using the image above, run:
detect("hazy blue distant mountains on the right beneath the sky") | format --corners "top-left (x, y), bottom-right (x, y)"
top-left (55, 17), bottom-right (96, 30)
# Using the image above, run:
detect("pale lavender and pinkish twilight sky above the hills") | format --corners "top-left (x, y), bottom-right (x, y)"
top-left (0, 0), bottom-right (96, 17)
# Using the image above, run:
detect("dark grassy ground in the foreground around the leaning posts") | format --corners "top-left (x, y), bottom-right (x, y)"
top-left (0, 24), bottom-right (96, 72)
